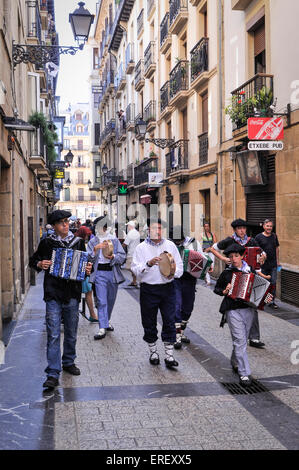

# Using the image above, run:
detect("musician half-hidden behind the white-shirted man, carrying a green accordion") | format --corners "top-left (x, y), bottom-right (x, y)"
top-left (171, 226), bottom-right (207, 349)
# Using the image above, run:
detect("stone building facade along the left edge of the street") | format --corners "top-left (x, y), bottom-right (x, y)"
top-left (0, 0), bottom-right (57, 337)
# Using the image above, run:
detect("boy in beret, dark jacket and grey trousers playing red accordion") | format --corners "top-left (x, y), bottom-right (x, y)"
top-left (214, 243), bottom-right (274, 387)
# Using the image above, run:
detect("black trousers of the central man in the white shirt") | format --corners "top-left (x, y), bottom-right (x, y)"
top-left (140, 282), bottom-right (176, 343)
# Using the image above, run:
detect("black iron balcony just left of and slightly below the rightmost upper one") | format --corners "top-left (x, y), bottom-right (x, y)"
top-left (169, 60), bottom-right (189, 107)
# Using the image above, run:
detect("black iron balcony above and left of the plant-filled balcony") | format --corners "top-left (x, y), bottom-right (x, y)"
top-left (190, 38), bottom-right (209, 89)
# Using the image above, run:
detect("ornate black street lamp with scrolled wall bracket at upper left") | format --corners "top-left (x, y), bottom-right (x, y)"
top-left (12, 2), bottom-right (94, 69)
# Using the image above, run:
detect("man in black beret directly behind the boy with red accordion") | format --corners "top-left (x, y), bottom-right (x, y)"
top-left (206, 219), bottom-right (267, 349)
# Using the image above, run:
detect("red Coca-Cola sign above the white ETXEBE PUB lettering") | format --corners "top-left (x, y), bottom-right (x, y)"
top-left (247, 117), bottom-right (283, 140)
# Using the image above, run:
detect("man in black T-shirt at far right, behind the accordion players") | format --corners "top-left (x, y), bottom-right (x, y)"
top-left (255, 219), bottom-right (279, 309)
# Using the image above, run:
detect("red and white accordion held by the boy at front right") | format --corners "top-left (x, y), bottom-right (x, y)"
top-left (228, 272), bottom-right (272, 310)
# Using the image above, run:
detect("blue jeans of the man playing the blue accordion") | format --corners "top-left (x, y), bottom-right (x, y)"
top-left (45, 299), bottom-right (79, 379)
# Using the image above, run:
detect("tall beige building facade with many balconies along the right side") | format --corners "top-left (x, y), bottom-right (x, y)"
top-left (93, 0), bottom-right (299, 303)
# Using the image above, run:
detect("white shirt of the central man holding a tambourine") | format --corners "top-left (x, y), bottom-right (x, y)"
top-left (131, 239), bottom-right (184, 284)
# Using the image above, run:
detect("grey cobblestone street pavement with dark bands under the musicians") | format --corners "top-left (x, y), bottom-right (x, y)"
top-left (0, 275), bottom-right (299, 450)
